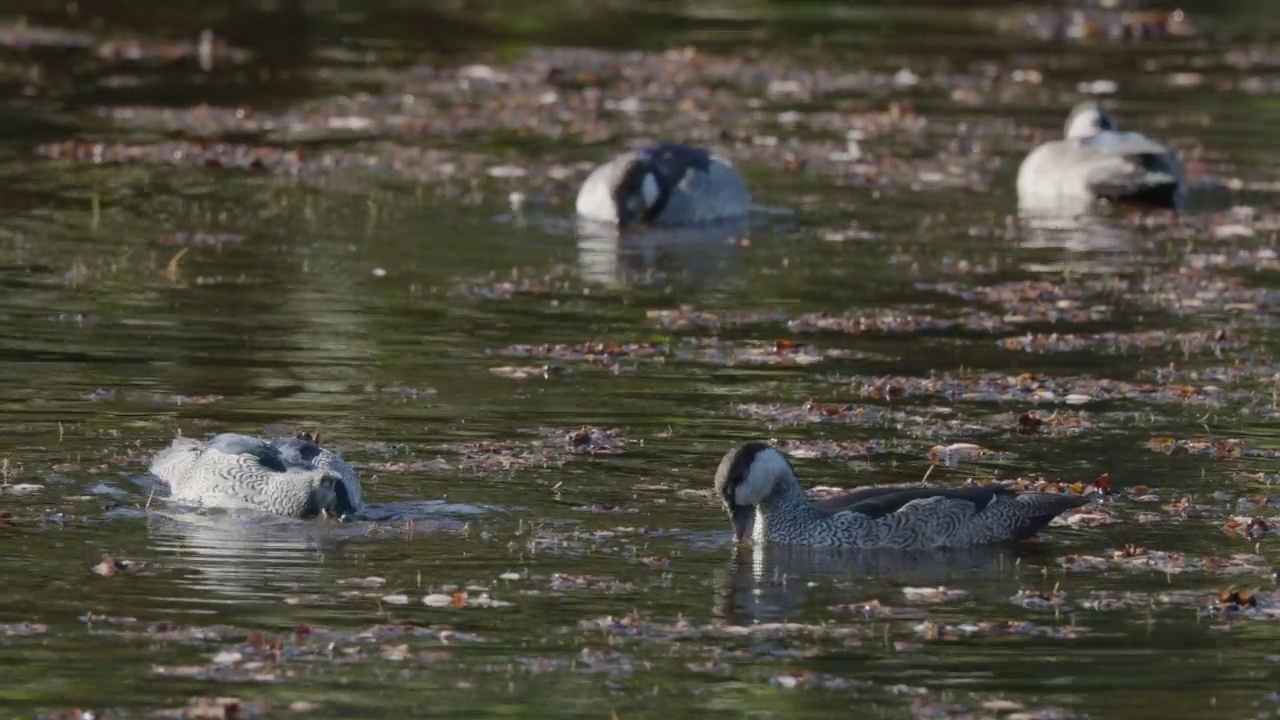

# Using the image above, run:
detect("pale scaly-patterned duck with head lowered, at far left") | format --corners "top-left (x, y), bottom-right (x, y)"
top-left (150, 433), bottom-right (365, 518)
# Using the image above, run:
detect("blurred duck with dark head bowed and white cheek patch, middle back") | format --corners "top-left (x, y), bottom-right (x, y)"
top-left (576, 142), bottom-right (751, 228)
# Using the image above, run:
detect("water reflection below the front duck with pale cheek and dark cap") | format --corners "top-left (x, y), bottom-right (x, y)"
top-left (713, 543), bottom-right (1044, 625)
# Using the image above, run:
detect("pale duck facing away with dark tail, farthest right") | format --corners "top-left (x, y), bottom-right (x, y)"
top-left (1018, 100), bottom-right (1187, 209)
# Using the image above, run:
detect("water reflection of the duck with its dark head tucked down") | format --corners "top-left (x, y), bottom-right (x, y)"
top-left (577, 218), bottom-right (750, 288)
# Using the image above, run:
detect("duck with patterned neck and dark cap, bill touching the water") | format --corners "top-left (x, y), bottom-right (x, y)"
top-left (716, 442), bottom-right (1089, 550)
